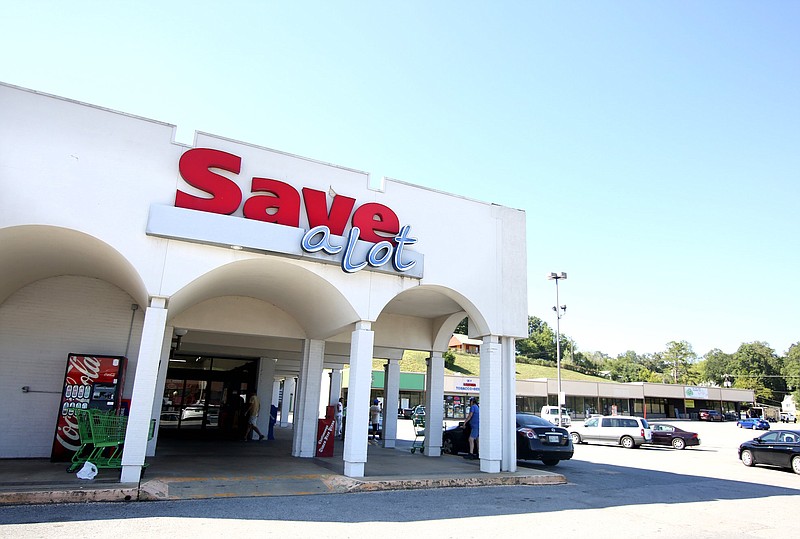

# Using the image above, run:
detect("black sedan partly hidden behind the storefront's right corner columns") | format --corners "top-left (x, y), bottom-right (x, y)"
top-left (442, 413), bottom-right (574, 466)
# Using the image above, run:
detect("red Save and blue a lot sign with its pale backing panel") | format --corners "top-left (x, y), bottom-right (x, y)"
top-left (147, 148), bottom-right (424, 278)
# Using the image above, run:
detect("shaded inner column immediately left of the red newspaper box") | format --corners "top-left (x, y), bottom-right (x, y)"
top-left (292, 339), bottom-right (325, 458)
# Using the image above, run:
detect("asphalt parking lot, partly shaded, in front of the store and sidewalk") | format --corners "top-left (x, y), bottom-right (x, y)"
top-left (0, 421), bottom-right (800, 539)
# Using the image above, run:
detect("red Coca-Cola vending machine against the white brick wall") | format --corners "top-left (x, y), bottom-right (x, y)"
top-left (50, 354), bottom-right (126, 462)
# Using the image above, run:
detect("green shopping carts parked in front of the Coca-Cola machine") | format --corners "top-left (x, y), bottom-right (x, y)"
top-left (67, 409), bottom-right (155, 473)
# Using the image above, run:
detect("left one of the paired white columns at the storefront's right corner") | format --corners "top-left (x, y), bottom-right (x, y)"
top-left (478, 335), bottom-right (503, 473)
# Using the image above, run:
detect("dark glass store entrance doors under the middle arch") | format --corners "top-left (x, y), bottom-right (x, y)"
top-left (158, 355), bottom-right (258, 440)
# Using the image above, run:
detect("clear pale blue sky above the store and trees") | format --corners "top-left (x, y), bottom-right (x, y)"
top-left (0, 1), bottom-right (800, 356)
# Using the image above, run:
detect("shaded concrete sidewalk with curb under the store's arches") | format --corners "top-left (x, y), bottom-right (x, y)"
top-left (0, 428), bottom-right (566, 505)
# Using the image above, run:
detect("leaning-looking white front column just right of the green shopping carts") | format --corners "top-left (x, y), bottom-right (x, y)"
top-left (120, 297), bottom-right (167, 483)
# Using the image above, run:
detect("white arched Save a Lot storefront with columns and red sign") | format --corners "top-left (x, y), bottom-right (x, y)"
top-left (0, 84), bottom-right (527, 482)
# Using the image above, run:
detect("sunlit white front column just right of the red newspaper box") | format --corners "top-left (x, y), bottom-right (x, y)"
top-left (344, 321), bottom-right (375, 477)
